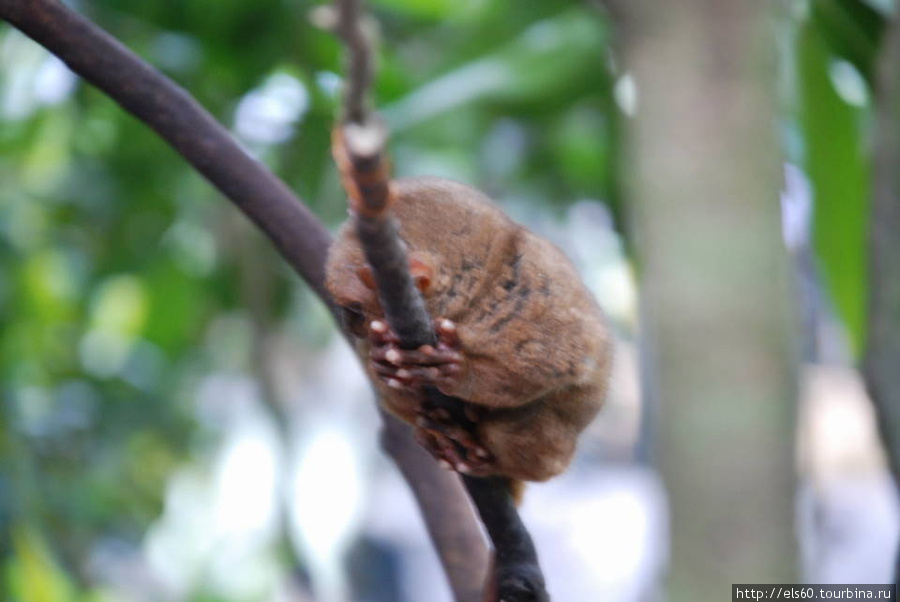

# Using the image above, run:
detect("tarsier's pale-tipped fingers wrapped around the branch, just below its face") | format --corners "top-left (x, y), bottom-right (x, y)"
top-left (369, 318), bottom-right (463, 390)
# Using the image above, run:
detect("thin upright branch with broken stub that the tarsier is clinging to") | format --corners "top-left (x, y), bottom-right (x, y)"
top-left (332, 0), bottom-right (549, 602)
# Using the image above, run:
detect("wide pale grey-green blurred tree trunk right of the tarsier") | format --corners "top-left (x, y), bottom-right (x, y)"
top-left (623, 0), bottom-right (796, 602)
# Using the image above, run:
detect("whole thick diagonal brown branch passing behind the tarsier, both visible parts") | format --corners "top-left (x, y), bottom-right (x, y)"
top-left (0, 0), bottom-right (484, 602)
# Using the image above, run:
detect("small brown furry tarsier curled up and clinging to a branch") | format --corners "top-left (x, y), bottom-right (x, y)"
top-left (326, 178), bottom-right (612, 490)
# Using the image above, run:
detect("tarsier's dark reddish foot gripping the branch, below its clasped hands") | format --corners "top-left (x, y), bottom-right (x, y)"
top-left (416, 409), bottom-right (494, 477)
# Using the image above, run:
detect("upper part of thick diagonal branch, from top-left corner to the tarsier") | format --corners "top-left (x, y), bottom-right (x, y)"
top-left (0, 0), bottom-right (331, 299)
